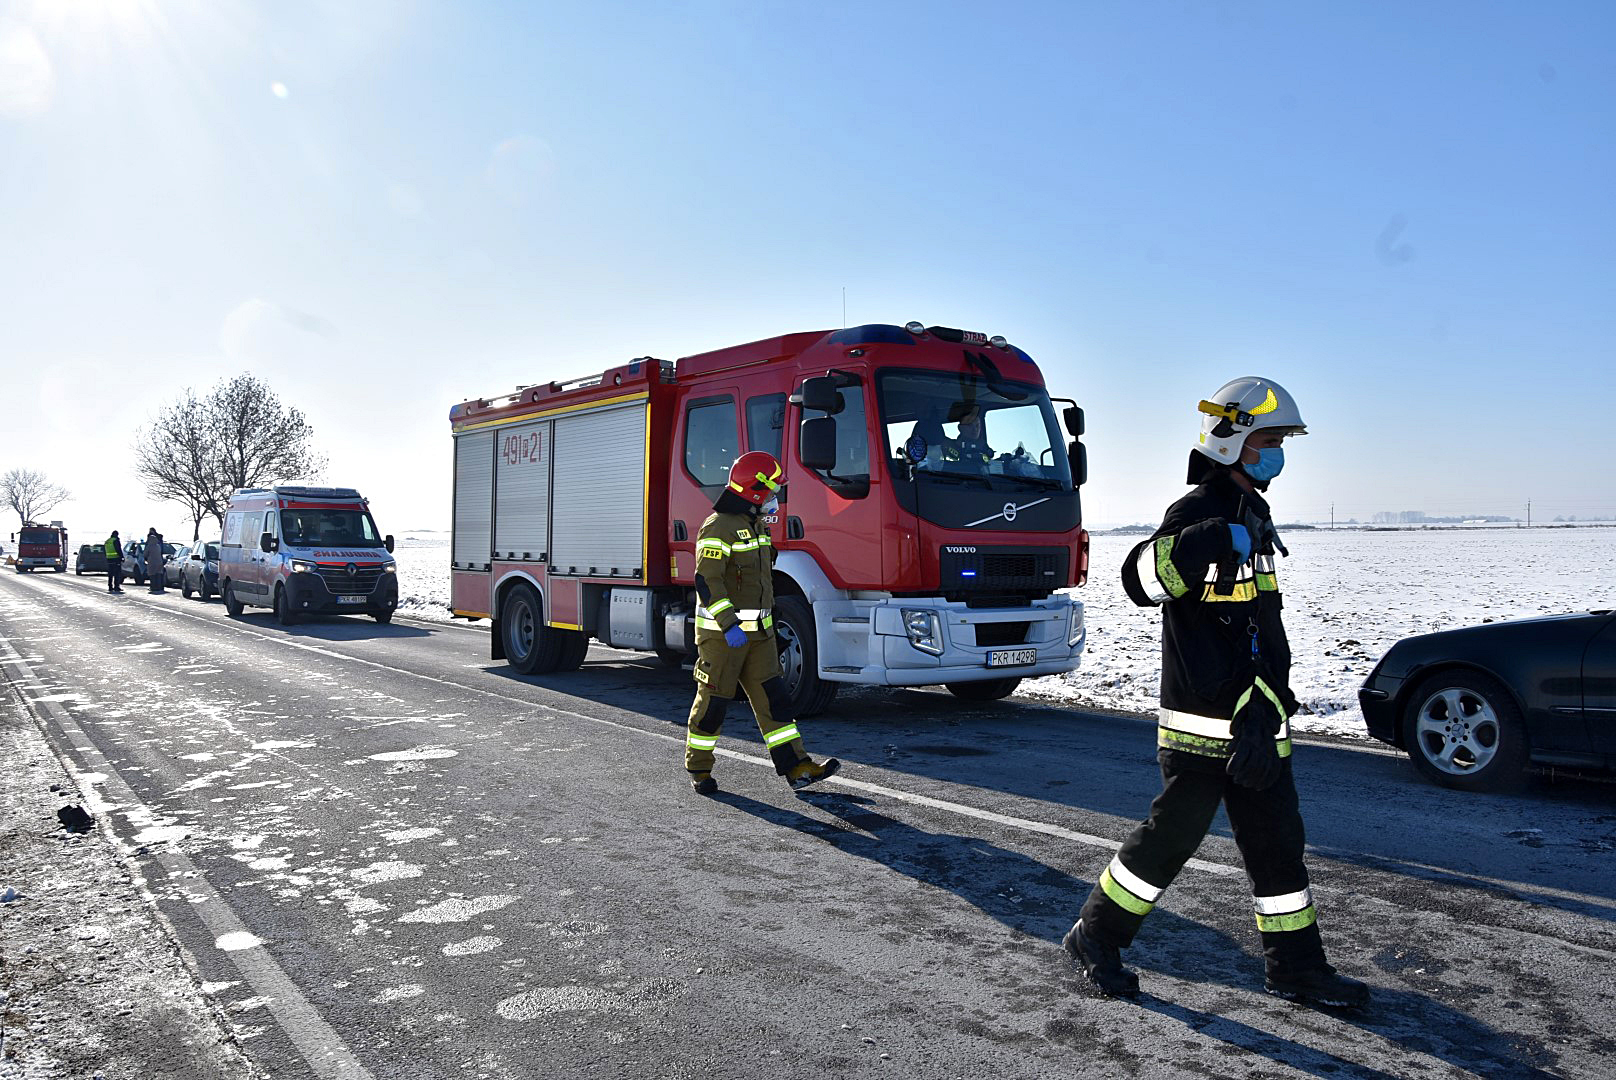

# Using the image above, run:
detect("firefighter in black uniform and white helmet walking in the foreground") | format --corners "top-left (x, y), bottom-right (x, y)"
top-left (1062, 377), bottom-right (1369, 1007)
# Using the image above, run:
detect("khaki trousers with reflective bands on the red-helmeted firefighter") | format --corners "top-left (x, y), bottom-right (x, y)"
top-left (685, 631), bottom-right (808, 776)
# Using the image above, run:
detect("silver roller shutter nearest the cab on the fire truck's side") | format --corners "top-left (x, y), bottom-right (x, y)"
top-left (549, 401), bottom-right (645, 579)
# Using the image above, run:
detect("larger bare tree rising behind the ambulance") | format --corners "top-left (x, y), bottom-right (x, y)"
top-left (134, 373), bottom-right (325, 540)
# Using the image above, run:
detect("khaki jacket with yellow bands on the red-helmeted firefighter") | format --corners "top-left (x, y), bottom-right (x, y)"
top-left (696, 513), bottom-right (774, 640)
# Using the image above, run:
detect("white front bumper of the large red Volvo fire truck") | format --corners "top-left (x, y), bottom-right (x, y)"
top-left (814, 595), bottom-right (1088, 686)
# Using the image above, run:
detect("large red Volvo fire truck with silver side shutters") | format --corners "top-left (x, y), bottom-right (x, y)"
top-left (449, 322), bottom-right (1089, 716)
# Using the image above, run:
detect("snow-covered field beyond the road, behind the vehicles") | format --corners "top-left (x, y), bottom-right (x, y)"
top-left (396, 527), bottom-right (1616, 736)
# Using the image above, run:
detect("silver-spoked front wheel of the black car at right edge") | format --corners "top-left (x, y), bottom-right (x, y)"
top-left (1403, 669), bottom-right (1530, 791)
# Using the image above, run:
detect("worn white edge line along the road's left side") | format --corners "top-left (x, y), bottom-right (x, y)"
top-left (3, 643), bottom-right (373, 1080)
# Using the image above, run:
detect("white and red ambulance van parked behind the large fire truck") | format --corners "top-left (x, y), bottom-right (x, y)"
top-left (218, 487), bottom-right (399, 626)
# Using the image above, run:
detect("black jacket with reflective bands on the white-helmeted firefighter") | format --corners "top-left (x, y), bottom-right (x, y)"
top-left (1122, 469), bottom-right (1296, 766)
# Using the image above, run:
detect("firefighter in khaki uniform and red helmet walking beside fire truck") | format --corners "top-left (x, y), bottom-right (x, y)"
top-left (685, 449), bottom-right (842, 795)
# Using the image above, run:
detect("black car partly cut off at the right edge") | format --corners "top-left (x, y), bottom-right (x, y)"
top-left (1357, 610), bottom-right (1616, 791)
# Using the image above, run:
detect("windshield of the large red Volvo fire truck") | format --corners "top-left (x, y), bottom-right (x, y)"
top-left (879, 370), bottom-right (1071, 491)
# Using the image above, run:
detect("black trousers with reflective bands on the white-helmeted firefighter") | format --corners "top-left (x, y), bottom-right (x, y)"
top-left (1081, 750), bottom-right (1325, 977)
